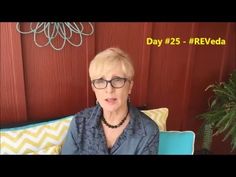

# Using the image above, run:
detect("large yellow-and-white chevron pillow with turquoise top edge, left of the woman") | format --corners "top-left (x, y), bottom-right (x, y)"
top-left (0, 116), bottom-right (73, 154)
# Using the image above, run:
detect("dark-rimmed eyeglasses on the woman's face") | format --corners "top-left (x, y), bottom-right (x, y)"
top-left (92, 77), bottom-right (129, 89)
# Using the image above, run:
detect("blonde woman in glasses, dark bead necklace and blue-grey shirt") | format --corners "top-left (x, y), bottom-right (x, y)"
top-left (61, 48), bottom-right (159, 154)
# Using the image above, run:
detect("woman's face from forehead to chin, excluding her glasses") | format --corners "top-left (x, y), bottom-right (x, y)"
top-left (92, 66), bottom-right (133, 112)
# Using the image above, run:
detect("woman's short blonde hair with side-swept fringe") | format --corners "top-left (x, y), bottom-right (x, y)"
top-left (89, 48), bottom-right (134, 80)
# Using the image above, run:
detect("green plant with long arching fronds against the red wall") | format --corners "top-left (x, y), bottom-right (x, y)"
top-left (199, 70), bottom-right (236, 152)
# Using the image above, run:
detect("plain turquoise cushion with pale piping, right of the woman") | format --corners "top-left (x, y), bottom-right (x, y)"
top-left (158, 131), bottom-right (195, 155)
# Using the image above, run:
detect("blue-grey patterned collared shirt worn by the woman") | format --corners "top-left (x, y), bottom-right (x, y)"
top-left (61, 105), bottom-right (159, 155)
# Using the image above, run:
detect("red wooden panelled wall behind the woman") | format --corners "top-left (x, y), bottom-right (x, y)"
top-left (0, 22), bottom-right (236, 153)
